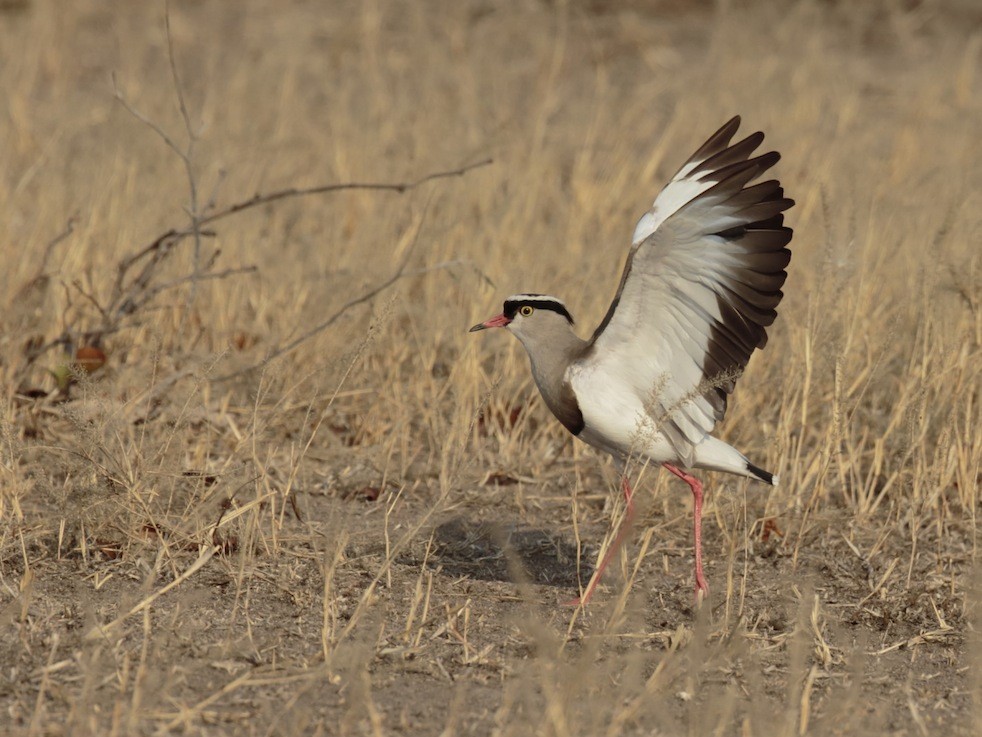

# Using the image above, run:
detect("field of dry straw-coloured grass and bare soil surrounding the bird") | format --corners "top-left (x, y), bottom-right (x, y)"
top-left (0, 0), bottom-right (982, 737)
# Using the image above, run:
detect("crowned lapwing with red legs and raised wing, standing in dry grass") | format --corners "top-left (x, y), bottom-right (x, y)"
top-left (470, 116), bottom-right (795, 605)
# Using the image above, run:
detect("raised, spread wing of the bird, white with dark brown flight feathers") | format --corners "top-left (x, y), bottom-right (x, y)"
top-left (584, 117), bottom-right (794, 462)
